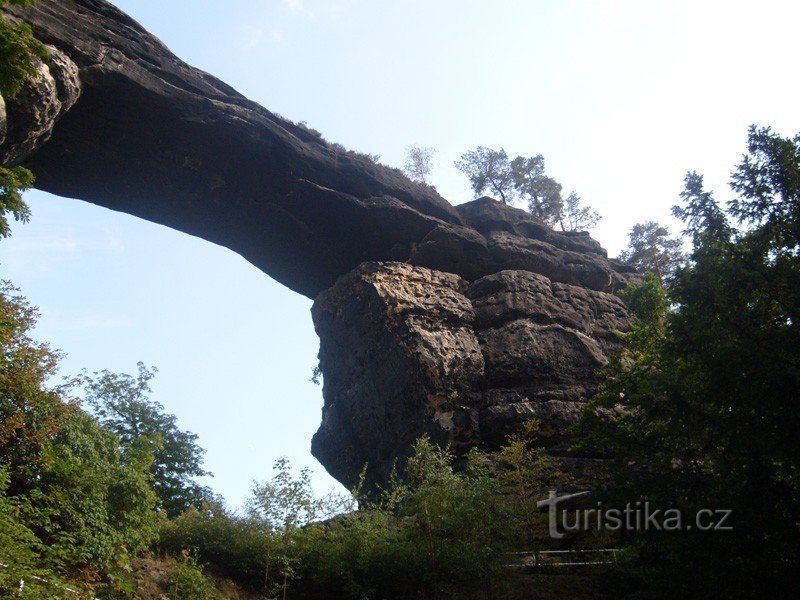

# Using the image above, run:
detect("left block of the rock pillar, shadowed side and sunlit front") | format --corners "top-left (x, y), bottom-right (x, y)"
top-left (312, 263), bottom-right (484, 485)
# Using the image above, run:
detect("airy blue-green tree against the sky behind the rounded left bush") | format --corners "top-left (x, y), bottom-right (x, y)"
top-left (81, 362), bottom-right (210, 517)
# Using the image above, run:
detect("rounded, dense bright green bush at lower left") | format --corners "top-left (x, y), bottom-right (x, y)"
top-left (25, 410), bottom-right (155, 571)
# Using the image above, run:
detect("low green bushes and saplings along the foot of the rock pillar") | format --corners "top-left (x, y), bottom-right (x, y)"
top-left (164, 436), bottom-right (563, 598)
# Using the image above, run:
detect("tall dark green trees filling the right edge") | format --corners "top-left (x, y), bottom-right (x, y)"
top-left (585, 128), bottom-right (800, 595)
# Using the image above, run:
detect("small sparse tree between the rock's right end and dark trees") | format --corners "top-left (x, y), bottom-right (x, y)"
top-left (619, 221), bottom-right (685, 285)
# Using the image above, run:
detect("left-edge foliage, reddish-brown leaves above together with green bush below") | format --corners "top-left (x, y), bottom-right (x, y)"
top-left (0, 283), bottom-right (155, 573)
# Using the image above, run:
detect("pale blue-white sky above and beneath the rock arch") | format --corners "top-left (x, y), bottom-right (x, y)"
top-left (0, 0), bottom-right (800, 507)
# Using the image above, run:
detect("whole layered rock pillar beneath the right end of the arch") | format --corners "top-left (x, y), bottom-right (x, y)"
top-left (312, 263), bottom-right (630, 485)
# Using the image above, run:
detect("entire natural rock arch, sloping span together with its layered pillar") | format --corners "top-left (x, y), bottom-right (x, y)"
top-left (0, 0), bottom-right (636, 485)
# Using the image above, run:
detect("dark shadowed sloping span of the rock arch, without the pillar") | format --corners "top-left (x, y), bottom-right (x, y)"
top-left (0, 0), bottom-right (461, 298)
